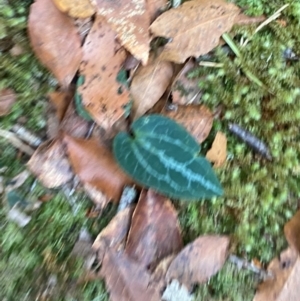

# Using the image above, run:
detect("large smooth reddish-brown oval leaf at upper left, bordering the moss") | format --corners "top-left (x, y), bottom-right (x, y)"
top-left (28, 0), bottom-right (82, 87)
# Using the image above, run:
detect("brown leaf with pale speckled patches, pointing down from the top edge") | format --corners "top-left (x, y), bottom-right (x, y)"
top-left (96, 0), bottom-right (150, 65)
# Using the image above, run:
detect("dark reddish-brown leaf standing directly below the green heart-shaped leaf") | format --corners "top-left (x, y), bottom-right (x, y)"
top-left (126, 189), bottom-right (182, 268)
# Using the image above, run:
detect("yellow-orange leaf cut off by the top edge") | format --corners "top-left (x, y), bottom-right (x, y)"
top-left (52, 0), bottom-right (95, 18)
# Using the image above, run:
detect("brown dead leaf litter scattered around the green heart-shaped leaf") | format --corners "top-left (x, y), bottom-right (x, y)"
top-left (20, 0), bottom-right (292, 301)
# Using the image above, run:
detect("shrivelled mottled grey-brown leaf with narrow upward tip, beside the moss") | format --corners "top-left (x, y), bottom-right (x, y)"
top-left (172, 59), bottom-right (201, 105)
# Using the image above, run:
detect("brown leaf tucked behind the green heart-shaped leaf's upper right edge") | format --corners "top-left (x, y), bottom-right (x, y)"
top-left (163, 105), bottom-right (213, 143)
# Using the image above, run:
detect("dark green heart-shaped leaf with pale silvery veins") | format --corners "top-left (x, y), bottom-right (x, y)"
top-left (113, 115), bottom-right (223, 200)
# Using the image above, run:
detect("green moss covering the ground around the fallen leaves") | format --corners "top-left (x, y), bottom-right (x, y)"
top-left (0, 0), bottom-right (300, 301)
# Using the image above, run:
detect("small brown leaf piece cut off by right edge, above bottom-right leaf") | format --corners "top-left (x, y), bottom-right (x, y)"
top-left (284, 210), bottom-right (300, 253)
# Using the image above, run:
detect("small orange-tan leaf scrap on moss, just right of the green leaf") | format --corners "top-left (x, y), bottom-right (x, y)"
top-left (206, 132), bottom-right (227, 167)
